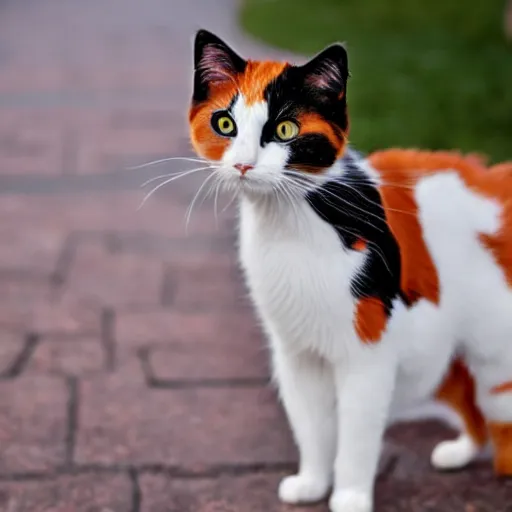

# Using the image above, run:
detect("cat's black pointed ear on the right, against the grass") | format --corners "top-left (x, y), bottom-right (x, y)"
top-left (301, 43), bottom-right (348, 98)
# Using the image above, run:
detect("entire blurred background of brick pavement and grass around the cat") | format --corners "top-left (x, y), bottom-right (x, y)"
top-left (0, 0), bottom-right (512, 512)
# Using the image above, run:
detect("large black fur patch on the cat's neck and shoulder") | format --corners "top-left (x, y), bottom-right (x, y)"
top-left (306, 162), bottom-right (407, 315)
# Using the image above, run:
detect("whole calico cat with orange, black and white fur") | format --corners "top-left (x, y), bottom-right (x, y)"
top-left (189, 30), bottom-right (512, 512)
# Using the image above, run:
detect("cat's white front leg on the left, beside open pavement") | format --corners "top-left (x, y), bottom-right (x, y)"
top-left (273, 338), bottom-right (336, 504)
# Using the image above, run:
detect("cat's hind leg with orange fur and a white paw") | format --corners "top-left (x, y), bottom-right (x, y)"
top-left (431, 360), bottom-right (488, 470)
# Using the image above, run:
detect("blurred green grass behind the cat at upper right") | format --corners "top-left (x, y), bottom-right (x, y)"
top-left (241, 0), bottom-right (512, 161)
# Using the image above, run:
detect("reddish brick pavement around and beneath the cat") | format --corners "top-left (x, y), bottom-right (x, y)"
top-left (0, 0), bottom-right (512, 512)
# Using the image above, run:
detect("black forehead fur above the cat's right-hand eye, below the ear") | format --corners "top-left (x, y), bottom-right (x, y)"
top-left (264, 66), bottom-right (348, 132)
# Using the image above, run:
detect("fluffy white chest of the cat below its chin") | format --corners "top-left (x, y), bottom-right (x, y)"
top-left (240, 198), bottom-right (363, 350)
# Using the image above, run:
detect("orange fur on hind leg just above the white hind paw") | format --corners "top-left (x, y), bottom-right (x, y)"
top-left (435, 359), bottom-right (488, 446)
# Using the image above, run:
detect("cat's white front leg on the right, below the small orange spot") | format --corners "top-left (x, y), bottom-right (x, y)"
top-left (329, 342), bottom-right (396, 512)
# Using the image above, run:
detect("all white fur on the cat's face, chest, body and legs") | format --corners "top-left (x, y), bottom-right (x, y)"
top-left (208, 93), bottom-right (512, 512)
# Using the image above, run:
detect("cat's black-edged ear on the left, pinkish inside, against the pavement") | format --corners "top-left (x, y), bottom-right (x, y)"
top-left (193, 30), bottom-right (247, 101)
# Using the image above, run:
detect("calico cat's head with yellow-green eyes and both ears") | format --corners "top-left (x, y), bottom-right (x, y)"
top-left (189, 30), bottom-right (348, 196)
